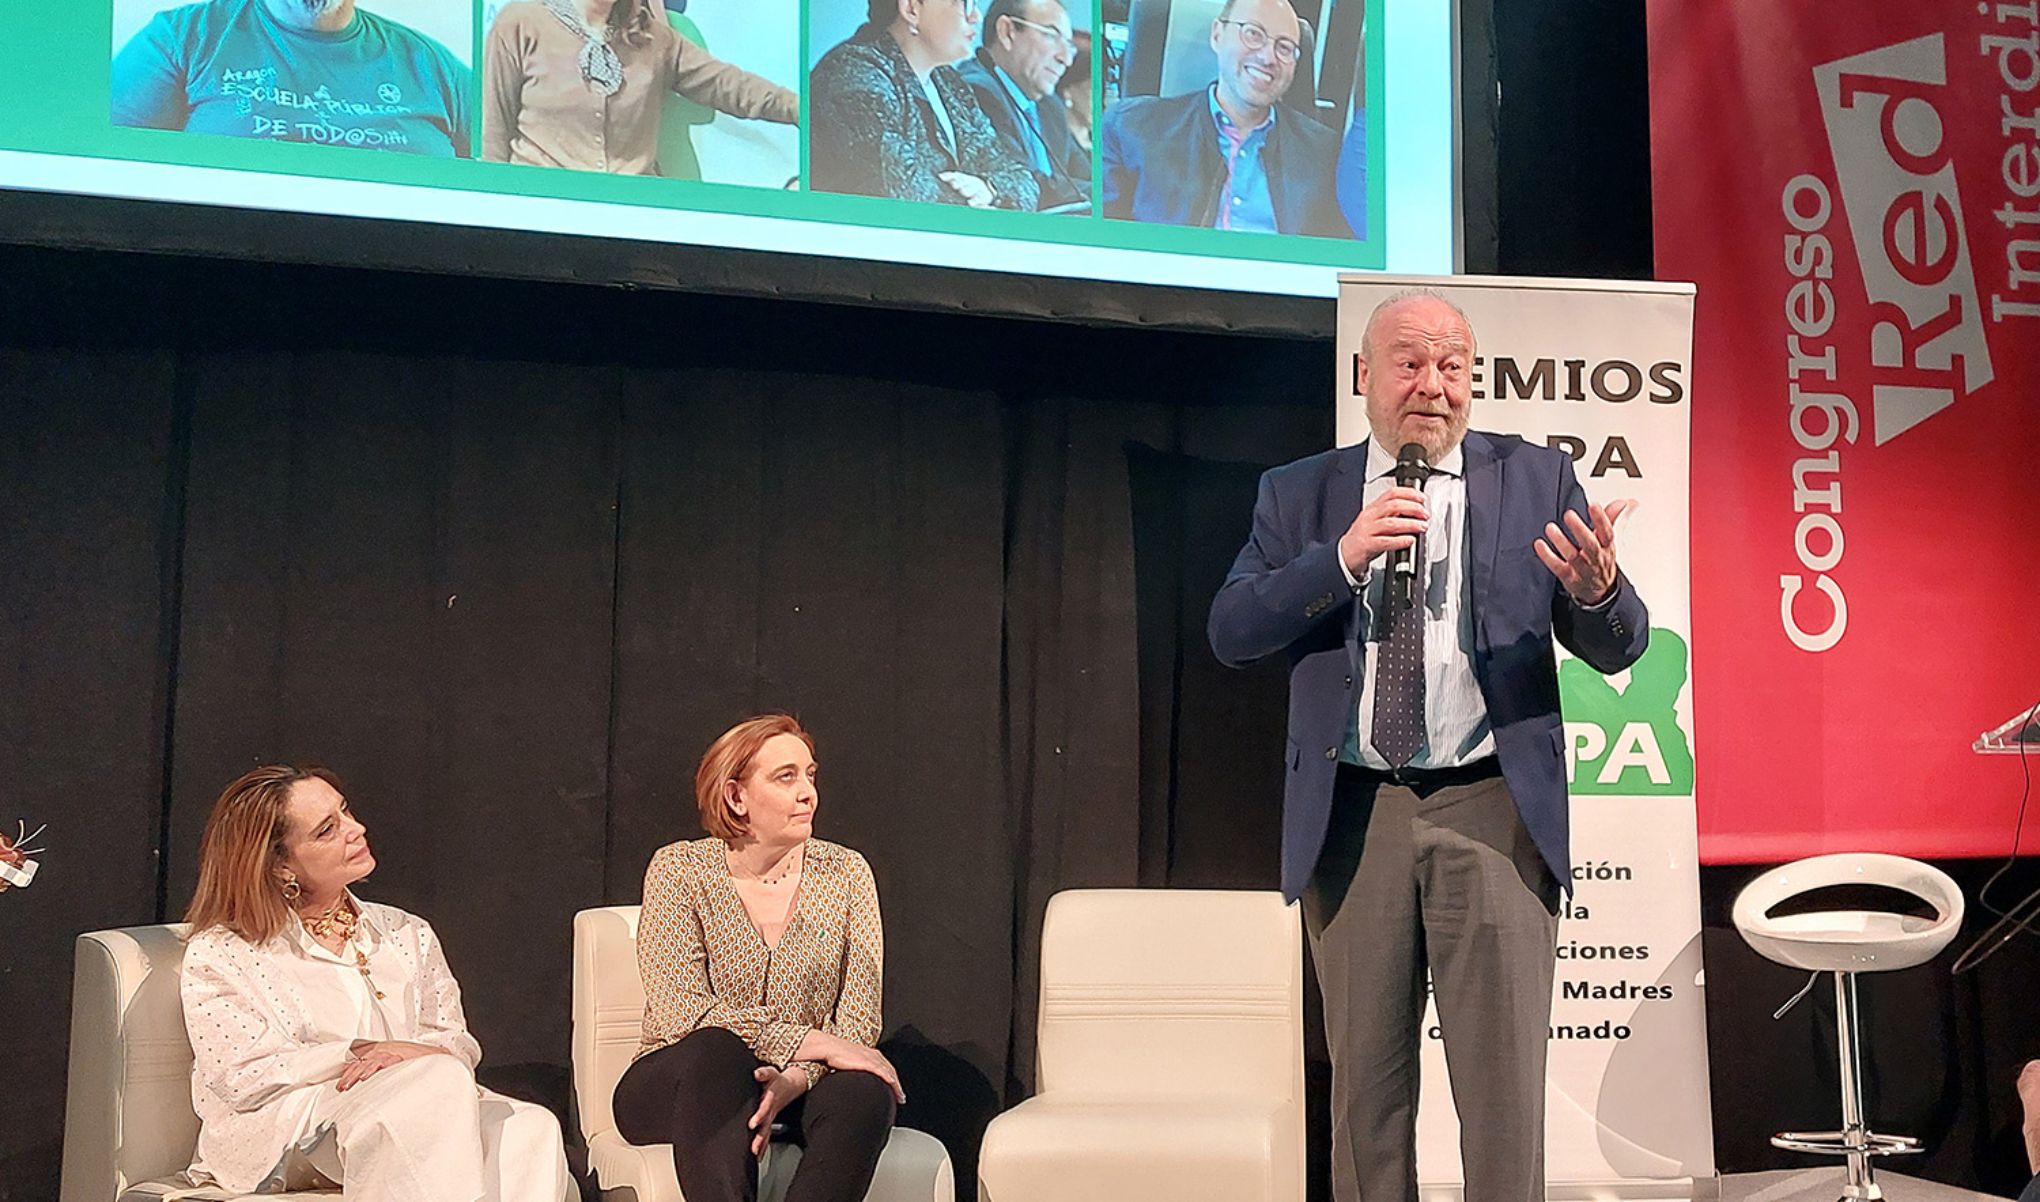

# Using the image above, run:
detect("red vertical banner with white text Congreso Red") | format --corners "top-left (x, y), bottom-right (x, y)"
top-left (1648, 0), bottom-right (2040, 863)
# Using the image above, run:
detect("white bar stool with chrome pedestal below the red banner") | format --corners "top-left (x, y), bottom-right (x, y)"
top-left (1734, 851), bottom-right (1962, 1202)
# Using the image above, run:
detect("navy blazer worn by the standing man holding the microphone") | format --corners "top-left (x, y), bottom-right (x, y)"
top-left (1210, 431), bottom-right (1650, 900)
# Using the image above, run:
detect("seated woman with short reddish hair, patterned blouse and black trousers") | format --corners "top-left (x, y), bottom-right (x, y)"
top-left (614, 714), bottom-right (906, 1202)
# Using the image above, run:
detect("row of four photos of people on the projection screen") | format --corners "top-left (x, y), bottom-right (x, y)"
top-left (108, 0), bottom-right (1381, 239)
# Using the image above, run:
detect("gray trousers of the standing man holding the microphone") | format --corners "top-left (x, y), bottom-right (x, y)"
top-left (1304, 765), bottom-right (1559, 1202)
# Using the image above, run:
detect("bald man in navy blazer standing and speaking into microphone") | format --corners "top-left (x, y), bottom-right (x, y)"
top-left (1210, 290), bottom-right (1650, 1202)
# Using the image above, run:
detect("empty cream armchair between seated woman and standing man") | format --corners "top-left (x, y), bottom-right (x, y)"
top-left (977, 890), bottom-right (1304, 1202)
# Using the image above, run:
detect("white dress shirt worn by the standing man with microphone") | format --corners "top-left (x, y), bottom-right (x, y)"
top-left (1338, 439), bottom-right (1495, 771)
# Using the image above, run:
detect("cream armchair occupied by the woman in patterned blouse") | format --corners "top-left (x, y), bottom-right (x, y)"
top-left (567, 906), bottom-right (957, 1202)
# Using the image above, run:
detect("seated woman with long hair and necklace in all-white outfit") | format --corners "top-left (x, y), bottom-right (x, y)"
top-left (182, 765), bottom-right (577, 1202)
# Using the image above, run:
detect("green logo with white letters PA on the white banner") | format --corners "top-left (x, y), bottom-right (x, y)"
top-left (1559, 627), bottom-right (1693, 796)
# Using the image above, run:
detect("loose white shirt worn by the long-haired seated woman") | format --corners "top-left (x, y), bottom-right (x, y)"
top-left (180, 900), bottom-right (481, 1192)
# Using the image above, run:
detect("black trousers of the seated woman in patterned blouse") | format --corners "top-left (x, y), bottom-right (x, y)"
top-left (612, 1026), bottom-right (894, 1202)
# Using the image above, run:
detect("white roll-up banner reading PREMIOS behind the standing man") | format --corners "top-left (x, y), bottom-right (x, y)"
top-left (1336, 276), bottom-right (1714, 1202)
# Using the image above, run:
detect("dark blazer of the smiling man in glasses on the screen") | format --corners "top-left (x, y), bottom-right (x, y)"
top-left (1098, 88), bottom-right (1353, 239)
